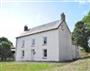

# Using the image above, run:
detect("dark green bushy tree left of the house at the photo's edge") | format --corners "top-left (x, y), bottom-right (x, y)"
top-left (0, 37), bottom-right (13, 61)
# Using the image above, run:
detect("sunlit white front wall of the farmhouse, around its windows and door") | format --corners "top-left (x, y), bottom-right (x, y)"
top-left (16, 30), bottom-right (59, 61)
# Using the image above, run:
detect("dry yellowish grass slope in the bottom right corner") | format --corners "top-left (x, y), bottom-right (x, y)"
top-left (49, 58), bottom-right (90, 71)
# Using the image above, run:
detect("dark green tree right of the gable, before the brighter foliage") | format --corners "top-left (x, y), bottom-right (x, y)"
top-left (72, 21), bottom-right (90, 52)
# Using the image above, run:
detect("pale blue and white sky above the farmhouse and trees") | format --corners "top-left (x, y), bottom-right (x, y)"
top-left (0, 0), bottom-right (90, 46)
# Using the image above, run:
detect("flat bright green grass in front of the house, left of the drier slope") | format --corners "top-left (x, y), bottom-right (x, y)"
top-left (0, 62), bottom-right (65, 71)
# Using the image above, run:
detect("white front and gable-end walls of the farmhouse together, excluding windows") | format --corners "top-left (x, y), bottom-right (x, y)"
top-left (16, 23), bottom-right (79, 61)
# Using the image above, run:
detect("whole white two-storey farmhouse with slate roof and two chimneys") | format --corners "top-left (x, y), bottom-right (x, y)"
top-left (16, 13), bottom-right (79, 61)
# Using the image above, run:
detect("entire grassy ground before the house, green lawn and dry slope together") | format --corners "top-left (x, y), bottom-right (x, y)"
top-left (0, 52), bottom-right (90, 71)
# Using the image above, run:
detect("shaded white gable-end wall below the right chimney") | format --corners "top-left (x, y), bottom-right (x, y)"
top-left (59, 23), bottom-right (73, 61)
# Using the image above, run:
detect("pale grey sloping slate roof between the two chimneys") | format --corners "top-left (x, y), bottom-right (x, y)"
top-left (17, 20), bottom-right (61, 38)
